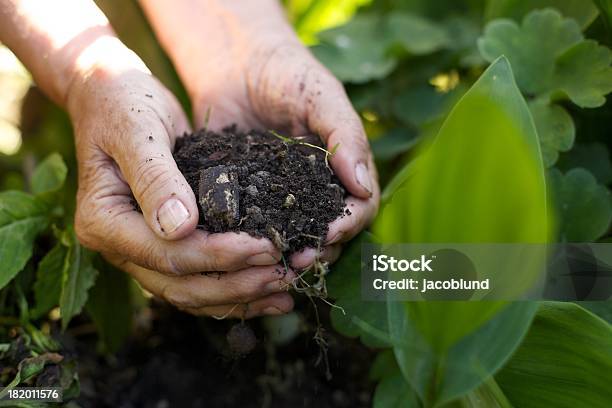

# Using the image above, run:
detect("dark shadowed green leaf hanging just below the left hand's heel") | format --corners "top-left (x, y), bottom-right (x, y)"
top-left (86, 257), bottom-right (133, 353)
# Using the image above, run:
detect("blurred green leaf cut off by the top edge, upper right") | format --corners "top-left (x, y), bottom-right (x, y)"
top-left (485, 0), bottom-right (596, 28)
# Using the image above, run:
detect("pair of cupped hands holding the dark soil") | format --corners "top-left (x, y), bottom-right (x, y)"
top-left (67, 11), bottom-right (379, 318)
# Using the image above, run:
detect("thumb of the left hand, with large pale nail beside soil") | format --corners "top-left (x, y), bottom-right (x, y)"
top-left (107, 91), bottom-right (198, 240)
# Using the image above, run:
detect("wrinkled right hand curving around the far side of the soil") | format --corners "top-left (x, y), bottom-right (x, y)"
top-left (183, 41), bottom-right (380, 268)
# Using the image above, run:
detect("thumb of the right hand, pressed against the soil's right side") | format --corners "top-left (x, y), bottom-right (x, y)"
top-left (306, 71), bottom-right (378, 198)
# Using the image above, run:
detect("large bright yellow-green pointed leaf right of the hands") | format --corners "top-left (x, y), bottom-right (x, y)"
top-left (374, 58), bottom-right (548, 353)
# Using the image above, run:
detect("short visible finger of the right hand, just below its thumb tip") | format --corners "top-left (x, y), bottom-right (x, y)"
top-left (325, 193), bottom-right (378, 245)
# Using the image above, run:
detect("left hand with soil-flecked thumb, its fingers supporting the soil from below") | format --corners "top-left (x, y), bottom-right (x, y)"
top-left (68, 40), bottom-right (295, 317)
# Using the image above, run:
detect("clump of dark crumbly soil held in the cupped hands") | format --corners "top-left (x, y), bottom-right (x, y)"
top-left (174, 126), bottom-right (346, 253)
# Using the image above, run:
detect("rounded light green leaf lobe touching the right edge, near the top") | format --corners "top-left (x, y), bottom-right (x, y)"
top-left (553, 40), bottom-right (612, 108)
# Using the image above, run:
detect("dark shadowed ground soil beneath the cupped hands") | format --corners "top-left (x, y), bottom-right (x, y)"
top-left (74, 299), bottom-right (374, 408)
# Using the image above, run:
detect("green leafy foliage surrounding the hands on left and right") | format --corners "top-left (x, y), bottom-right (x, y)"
top-left (0, 0), bottom-right (612, 408)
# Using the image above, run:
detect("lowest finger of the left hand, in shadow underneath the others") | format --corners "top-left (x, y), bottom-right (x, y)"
top-left (183, 293), bottom-right (294, 319)
